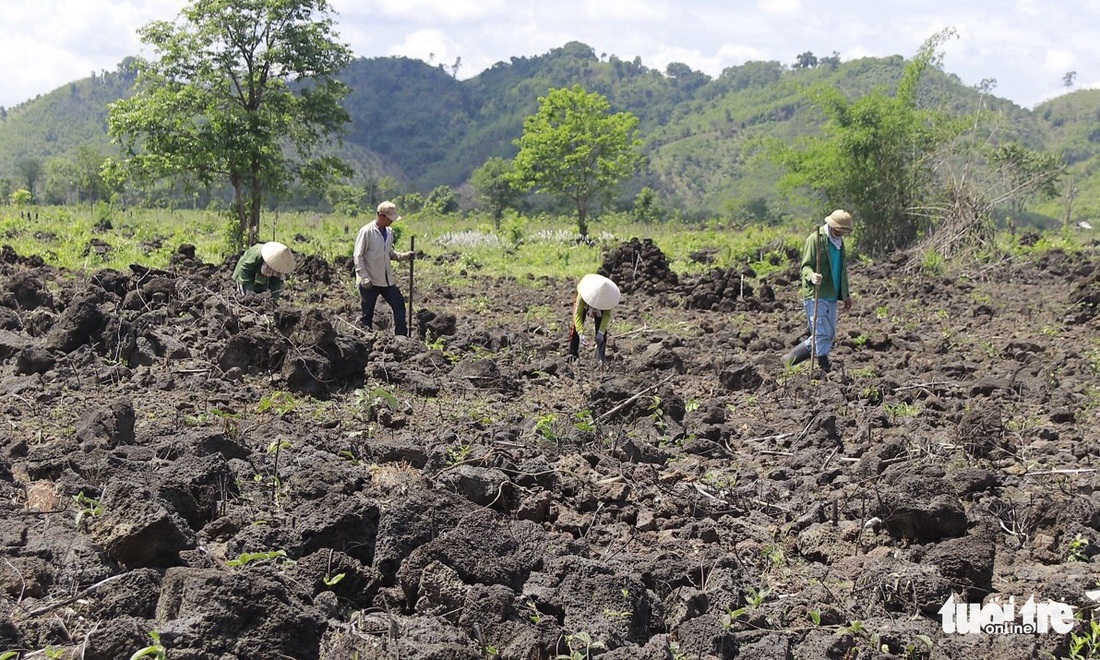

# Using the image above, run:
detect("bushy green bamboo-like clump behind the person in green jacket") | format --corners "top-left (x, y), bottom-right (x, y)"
top-left (772, 30), bottom-right (961, 254)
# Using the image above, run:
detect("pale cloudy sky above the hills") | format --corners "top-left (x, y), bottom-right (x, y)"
top-left (0, 0), bottom-right (1100, 108)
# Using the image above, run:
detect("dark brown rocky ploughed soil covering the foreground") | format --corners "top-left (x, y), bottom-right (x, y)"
top-left (0, 234), bottom-right (1100, 660)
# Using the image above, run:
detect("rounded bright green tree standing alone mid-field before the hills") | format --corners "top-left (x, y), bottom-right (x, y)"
top-left (513, 85), bottom-right (641, 237)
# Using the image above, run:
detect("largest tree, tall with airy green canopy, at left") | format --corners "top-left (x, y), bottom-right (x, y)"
top-left (108, 0), bottom-right (351, 242)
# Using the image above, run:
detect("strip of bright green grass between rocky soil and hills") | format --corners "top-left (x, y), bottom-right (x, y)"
top-left (0, 205), bottom-right (1096, 277)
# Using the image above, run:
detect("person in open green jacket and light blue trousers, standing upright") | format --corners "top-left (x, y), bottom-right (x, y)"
top-left (782, 209), bottom-right (851, 372)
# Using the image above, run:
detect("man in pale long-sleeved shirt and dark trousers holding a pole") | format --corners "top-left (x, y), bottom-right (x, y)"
top-left (352, 201), bottom-right (413, 337)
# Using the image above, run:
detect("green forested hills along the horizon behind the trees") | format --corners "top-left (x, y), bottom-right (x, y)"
top-left (0, 42), bottom-right (1100, 222)
